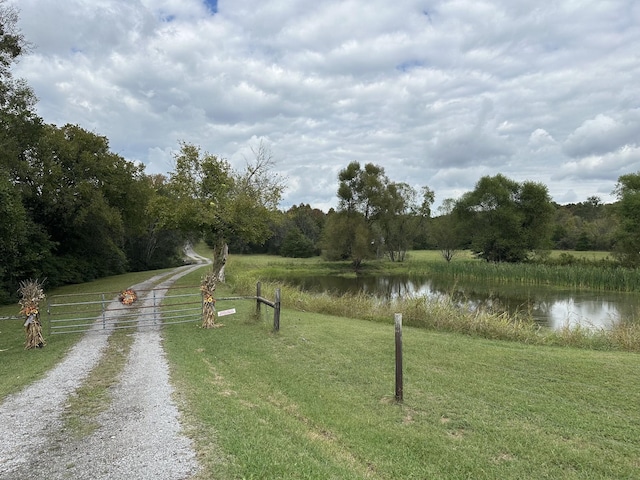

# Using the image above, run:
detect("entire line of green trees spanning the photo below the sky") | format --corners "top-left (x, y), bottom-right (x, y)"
top-left (0, 2), bottom-right (640, 302)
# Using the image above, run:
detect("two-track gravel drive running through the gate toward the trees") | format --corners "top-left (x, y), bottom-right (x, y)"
top-left (0, 250), bottom-right (208, 480)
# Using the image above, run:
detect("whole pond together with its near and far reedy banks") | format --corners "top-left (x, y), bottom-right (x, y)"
top-left (229, 251), bottom-right (640, 351)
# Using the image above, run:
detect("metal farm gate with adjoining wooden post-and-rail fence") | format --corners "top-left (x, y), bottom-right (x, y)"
top-left (47, 282), bottom-right (280, 335)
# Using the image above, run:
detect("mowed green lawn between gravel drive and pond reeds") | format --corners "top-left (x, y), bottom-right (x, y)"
top-left (164, 262), bottom-right (640, 479)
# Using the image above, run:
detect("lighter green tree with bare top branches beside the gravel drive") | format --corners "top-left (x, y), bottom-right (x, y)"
top-left (158, 142), bottom-right (284, 275)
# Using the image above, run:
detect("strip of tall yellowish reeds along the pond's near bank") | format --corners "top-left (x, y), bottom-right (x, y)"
top-left (230, 273), bottom-right (640, 352)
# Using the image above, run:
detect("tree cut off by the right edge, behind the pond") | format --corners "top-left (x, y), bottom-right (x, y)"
top-left (614, 172), bottom-right (640, 268)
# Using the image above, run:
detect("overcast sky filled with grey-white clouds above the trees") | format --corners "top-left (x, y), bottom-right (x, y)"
top-left (6, 0), bottom-right (640, 211)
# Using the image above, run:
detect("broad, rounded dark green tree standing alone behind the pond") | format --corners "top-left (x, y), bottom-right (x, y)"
top-left (454, 174), bottom-right (554, 262)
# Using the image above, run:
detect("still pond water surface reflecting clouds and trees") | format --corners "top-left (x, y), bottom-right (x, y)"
top-left (281, 275), bottom-right (640, 329)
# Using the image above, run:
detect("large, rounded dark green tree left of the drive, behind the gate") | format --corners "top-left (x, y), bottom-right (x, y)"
top-left (25, 125), bottom-right (145, 283)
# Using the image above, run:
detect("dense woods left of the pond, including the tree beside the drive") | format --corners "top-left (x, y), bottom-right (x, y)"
top-left (0, 0), bottom-right (283, 303)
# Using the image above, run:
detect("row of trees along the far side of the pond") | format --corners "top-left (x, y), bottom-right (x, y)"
top-left (272, 166), bottom-right (640, 269)
